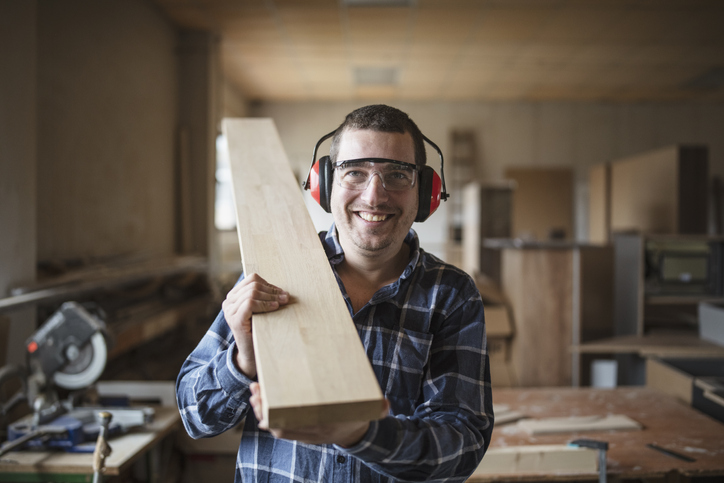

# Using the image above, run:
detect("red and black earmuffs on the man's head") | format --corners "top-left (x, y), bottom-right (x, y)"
top-left (302, 130), bottom-right (450, 223)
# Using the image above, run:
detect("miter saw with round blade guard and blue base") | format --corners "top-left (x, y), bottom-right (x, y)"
top-left (0, 302), bottom-right (154, 455)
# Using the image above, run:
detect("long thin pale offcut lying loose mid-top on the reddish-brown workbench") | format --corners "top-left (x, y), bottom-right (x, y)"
top-left (518, 414), bottom-right (641, 435)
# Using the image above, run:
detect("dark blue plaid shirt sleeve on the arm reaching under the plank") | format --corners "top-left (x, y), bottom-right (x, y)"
top-left (338, 290), bottom-right (493, 481)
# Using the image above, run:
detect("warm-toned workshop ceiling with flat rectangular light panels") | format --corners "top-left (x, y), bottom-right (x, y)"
top-left (155, 0), bottom-right (724, 101)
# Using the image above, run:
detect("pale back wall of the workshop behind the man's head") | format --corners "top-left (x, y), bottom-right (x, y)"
top-left (252, 102), bottom-right (724, 254)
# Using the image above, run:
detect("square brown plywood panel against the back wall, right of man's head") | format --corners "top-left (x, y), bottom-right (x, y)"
top-left (505, 168), bottom-right (574, 240)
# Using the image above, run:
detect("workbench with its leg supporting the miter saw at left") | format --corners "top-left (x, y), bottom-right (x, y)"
top-left (0, 406), bottom-right (181, 483)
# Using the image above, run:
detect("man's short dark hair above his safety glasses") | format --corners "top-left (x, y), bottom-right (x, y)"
top-left (329, 104), bottom-right (427, 166)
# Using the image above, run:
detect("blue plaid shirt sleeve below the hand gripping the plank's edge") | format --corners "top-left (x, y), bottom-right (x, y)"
top-left (176, 311), bottom-right (253, 439)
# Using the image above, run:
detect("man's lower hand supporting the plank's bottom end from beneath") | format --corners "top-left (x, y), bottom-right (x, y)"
top-left (249, 382), bottom-right (390, 448)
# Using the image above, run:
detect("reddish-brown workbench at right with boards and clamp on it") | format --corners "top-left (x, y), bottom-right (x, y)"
top-left (468, 387), bottom-right (724, 483)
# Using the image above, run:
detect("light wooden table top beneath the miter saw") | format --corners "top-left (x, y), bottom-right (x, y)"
top-left (0, 407), bottom-right (181, 475)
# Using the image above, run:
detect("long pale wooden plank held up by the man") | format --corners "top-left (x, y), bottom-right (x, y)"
top-left (223, 119), bottom-right (383, 428)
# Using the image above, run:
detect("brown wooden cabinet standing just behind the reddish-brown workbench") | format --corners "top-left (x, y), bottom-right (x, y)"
top-left (485, 244), bottom-right (613, 387)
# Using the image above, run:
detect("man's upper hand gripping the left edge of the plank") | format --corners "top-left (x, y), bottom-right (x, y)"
top-left (221, 273), bottom-right (289, 379)
